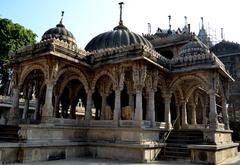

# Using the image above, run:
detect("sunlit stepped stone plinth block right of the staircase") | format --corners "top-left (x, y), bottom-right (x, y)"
top-left (188, 130), bottom-right (239, 164)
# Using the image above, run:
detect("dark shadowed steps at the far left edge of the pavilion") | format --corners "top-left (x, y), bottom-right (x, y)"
top-left (0, 125), bottom-right (20, 143)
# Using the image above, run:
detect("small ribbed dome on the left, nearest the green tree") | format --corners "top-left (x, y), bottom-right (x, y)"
top-left (42, 21), bottom-right (76, 45)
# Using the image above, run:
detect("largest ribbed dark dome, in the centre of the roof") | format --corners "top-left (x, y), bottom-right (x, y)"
top-left (85, 24), bottom-right (153, 51)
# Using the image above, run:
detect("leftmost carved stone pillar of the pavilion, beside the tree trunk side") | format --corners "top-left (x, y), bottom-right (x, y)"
top-left (7, 86), bottom-right (19, 125)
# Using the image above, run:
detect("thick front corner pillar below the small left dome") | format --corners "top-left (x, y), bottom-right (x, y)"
top-left (41, 80), bottom-right (54, 123)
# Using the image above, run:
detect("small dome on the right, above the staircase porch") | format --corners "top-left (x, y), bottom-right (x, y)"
top-left (180, 35), bottom-right (210, 56)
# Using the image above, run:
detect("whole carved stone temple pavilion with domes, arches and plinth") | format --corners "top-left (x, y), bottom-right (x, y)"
top-left (0, 3), bottom-right (238, 164)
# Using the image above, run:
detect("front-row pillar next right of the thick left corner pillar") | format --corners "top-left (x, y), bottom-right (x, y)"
top-left (84, 90), bottom-right (93, 125)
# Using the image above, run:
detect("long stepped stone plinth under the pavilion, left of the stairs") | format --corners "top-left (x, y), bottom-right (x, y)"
top-left (0, 124), bottom-right (164, 163)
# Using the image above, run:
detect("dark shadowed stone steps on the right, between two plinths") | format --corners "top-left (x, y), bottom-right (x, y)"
top-left (158, 130), bottom-right (203, 160)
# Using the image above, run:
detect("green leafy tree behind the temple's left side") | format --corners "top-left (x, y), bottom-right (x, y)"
top-left (0, 18), bottom-right (37, 94)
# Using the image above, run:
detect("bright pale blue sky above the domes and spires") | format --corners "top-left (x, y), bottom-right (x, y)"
top-left (0, 0), bottom-right (240, 48)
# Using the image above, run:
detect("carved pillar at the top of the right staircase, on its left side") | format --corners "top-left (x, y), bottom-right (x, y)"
top-left (162, 94), bottom-right (172, 129)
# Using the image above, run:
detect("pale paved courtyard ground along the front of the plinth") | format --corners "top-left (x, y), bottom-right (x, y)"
top-left (7, 153), bottom-right (240, 165)
